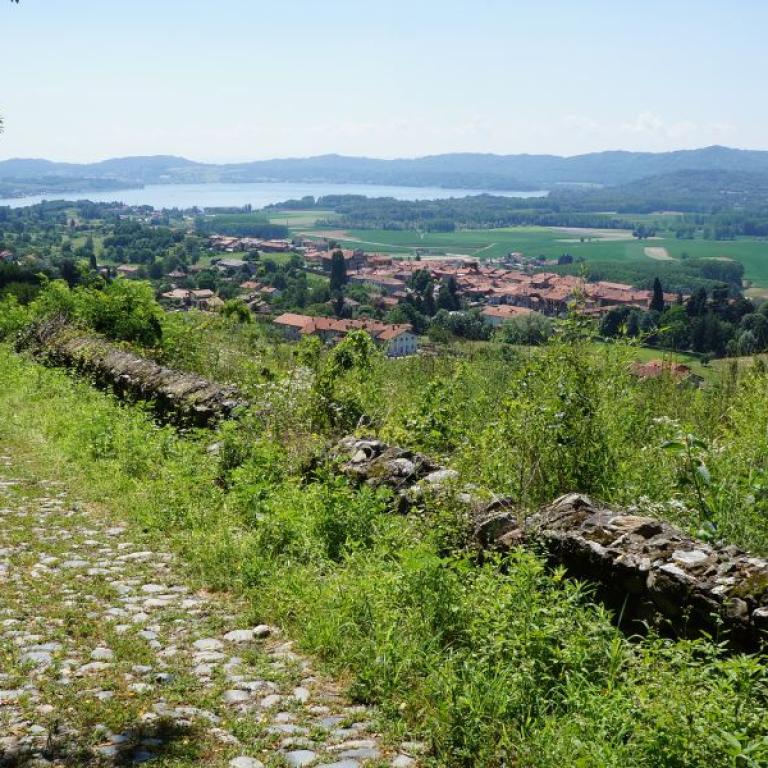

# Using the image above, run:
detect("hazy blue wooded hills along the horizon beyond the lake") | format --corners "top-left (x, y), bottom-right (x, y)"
top-left (0, 146), bottom-right (768, 190)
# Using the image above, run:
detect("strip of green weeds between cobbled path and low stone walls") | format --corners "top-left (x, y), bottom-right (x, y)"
top-left (0, 348), bottom-right (768, 767)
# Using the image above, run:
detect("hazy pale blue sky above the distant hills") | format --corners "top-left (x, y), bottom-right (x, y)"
top-left (0, 0), bottom-right (768, 161)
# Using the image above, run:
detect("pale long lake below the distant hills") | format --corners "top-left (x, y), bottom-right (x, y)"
top-left (0, 182), bottom-right (547, 208)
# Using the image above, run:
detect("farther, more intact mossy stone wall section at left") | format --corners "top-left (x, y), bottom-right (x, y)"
top-left (16, 319), bottom-right (245, 426)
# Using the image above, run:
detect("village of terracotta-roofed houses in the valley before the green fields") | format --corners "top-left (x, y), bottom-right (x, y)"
top-left (148, 235), bottom-right (680, 357)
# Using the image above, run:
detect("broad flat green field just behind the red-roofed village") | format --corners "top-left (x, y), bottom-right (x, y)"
top-left (290, 224), bottom-right (768, 292)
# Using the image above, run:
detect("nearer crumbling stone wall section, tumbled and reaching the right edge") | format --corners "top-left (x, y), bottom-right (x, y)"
top-left (334, 437), bottom-right (768, 649)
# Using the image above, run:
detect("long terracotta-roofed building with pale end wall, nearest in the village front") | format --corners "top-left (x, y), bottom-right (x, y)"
top-left (274, 312), bottom-right (418, 357)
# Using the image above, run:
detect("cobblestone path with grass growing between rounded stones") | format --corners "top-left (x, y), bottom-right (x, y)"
top-left (0, 457), bottom-right (421, 768)
